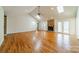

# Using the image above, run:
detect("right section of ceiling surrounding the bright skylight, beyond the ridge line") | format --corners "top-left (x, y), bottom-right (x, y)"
top-left (31, 6), bottom-right (77, 20)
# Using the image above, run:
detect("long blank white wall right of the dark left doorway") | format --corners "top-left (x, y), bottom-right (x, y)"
top-left (7, 14), bottom-right (37, 34)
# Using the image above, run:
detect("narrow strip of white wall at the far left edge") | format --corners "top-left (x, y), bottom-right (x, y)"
top-left (0, 7), bottom-right (4, 45)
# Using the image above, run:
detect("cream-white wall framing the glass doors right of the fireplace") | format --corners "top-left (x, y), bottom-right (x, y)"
top-left (55, 18), bottom-right (76, 34)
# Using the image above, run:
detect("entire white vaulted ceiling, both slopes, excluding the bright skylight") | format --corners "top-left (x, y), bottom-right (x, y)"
top-left (3, 6), bottom-right (77, 20)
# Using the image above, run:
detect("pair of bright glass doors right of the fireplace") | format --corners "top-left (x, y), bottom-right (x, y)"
top-left (57, 21), bottom-right (69, 33)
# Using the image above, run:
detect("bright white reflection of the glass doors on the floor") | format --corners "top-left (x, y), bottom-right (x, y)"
top-left (57, 34), bottom-right (70, 49)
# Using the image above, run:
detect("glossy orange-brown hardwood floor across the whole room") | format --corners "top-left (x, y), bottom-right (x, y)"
top-left (0, 31), bottom-right (79, 53)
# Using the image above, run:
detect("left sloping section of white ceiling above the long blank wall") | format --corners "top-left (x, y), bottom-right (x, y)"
top-left (3, 6), bottom-right (36, 16)
